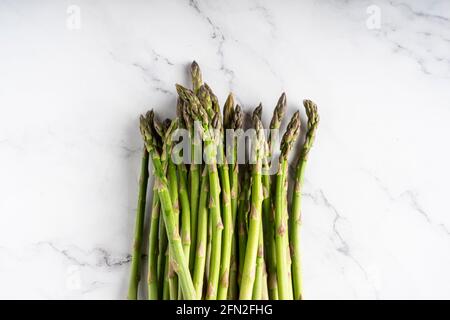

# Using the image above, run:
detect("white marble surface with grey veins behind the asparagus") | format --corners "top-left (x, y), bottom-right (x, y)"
top-left (0, 0), bottom-right (450, 299)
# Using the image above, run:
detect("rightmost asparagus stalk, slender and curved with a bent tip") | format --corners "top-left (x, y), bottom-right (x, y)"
top-left (290, 100), bottom-right (319, 300)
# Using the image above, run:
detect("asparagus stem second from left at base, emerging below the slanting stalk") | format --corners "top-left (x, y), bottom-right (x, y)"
top-left (147, 182), bottom-right (161, 300)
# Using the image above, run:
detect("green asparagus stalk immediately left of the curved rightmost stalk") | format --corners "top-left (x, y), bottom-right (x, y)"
top-left (275, 111), bottom-right (300, 300)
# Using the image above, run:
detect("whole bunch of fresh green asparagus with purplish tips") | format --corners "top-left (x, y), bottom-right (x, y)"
top-left (128, 61), bottom-right (319, 300)
